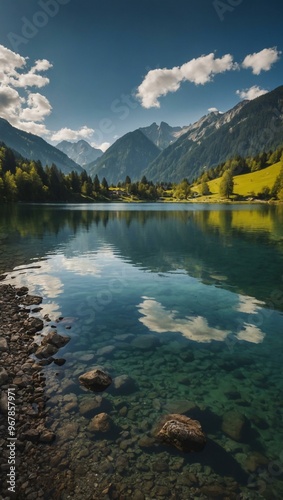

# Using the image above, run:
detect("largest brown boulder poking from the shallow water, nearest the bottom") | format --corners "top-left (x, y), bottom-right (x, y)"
top-left (155, 413), bottom-right (206, 453)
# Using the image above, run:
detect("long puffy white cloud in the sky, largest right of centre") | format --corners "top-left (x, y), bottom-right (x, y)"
top-left (137, 53), bottom-right (238, 108)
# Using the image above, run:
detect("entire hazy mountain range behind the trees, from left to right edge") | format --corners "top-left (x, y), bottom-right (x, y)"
top-left (0, 86), bottom-right (283, 185)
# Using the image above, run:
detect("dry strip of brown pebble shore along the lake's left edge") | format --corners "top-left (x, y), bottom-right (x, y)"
top-left (0, 284), bottom-right (68, 500)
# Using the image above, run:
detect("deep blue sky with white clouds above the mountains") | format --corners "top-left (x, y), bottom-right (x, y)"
top-left (0, 0), bottom-right (283, 149)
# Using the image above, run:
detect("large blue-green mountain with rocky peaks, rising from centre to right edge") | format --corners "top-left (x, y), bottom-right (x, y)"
top-left (85, 86), bottom-right (283, 184)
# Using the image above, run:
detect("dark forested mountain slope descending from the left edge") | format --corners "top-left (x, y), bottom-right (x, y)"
top-left (0, 118), bottom-right (83, 174)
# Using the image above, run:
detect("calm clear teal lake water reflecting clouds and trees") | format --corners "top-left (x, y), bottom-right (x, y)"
top-left (0, 204), bottom-right (283, 500)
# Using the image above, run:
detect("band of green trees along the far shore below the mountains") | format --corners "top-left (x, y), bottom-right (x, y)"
top-left (0, 143), bottom-right (283, 203)
